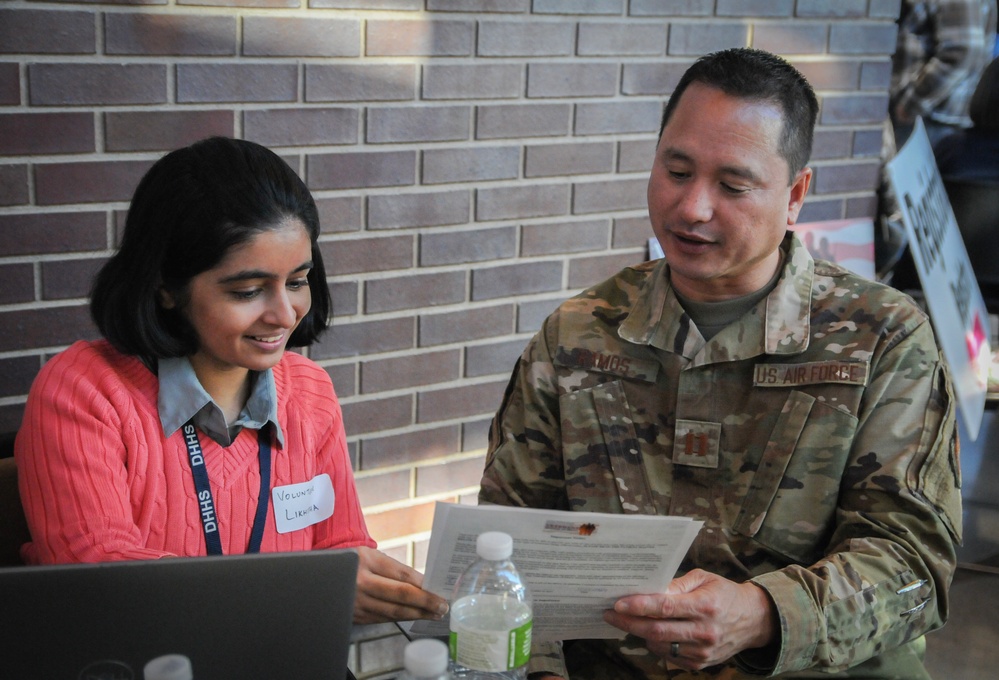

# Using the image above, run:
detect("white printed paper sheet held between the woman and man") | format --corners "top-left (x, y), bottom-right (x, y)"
top-left (410, 503), bottom-right (703, 641)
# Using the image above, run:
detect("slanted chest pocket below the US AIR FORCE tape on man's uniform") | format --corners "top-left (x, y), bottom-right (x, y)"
top-left (733, 391), bottom-right (857, 564)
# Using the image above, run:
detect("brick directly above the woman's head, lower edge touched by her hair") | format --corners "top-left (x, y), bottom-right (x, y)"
top-left (104, 110), bottom-right (235, 151)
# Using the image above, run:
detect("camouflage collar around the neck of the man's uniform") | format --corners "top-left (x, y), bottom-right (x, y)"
top-left (618, 231), bottom-right (815, 364)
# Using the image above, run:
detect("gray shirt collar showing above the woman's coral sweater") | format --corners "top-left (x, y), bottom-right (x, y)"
top-left (157, 357), bottom-right (284, 446)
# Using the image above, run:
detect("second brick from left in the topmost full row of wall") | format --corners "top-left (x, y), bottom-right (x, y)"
top-left (104, 13), bottom-right (236, 57)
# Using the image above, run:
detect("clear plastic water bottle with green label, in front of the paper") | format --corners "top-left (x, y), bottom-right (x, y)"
top-left (450, 531), bottom-right (533, 680)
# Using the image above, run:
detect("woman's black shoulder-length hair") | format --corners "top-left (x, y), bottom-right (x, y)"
top-left (90, 137), bottom-right (333, 363)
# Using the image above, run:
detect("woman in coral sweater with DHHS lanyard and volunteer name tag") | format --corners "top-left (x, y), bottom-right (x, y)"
top-left (15, 138), bottom-right (446, 623)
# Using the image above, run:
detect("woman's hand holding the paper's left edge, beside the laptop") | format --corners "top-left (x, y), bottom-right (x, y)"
top-left (354, 546), bottom-right (447, 624)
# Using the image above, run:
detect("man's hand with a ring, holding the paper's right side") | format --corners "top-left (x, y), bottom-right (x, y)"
top-left (604, 569), bottom-right (778, 670)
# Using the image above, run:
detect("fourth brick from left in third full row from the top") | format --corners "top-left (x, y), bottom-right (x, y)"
top-left (366, 106), bottom-right (471, 144)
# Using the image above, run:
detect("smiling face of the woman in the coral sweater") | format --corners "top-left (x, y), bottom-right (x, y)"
top-left (161, 218), bottom-right (312, 393)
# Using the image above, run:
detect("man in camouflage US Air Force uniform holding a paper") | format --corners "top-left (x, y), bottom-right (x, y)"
top-left (479, 49), bottom-right (961, 680)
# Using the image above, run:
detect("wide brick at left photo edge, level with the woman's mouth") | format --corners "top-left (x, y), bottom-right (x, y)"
top-left (0, 304), bottom-right (98, 352)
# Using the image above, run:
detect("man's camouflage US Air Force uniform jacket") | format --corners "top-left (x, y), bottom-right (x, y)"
top-left (479, 234), bottom-right (961, 679)
